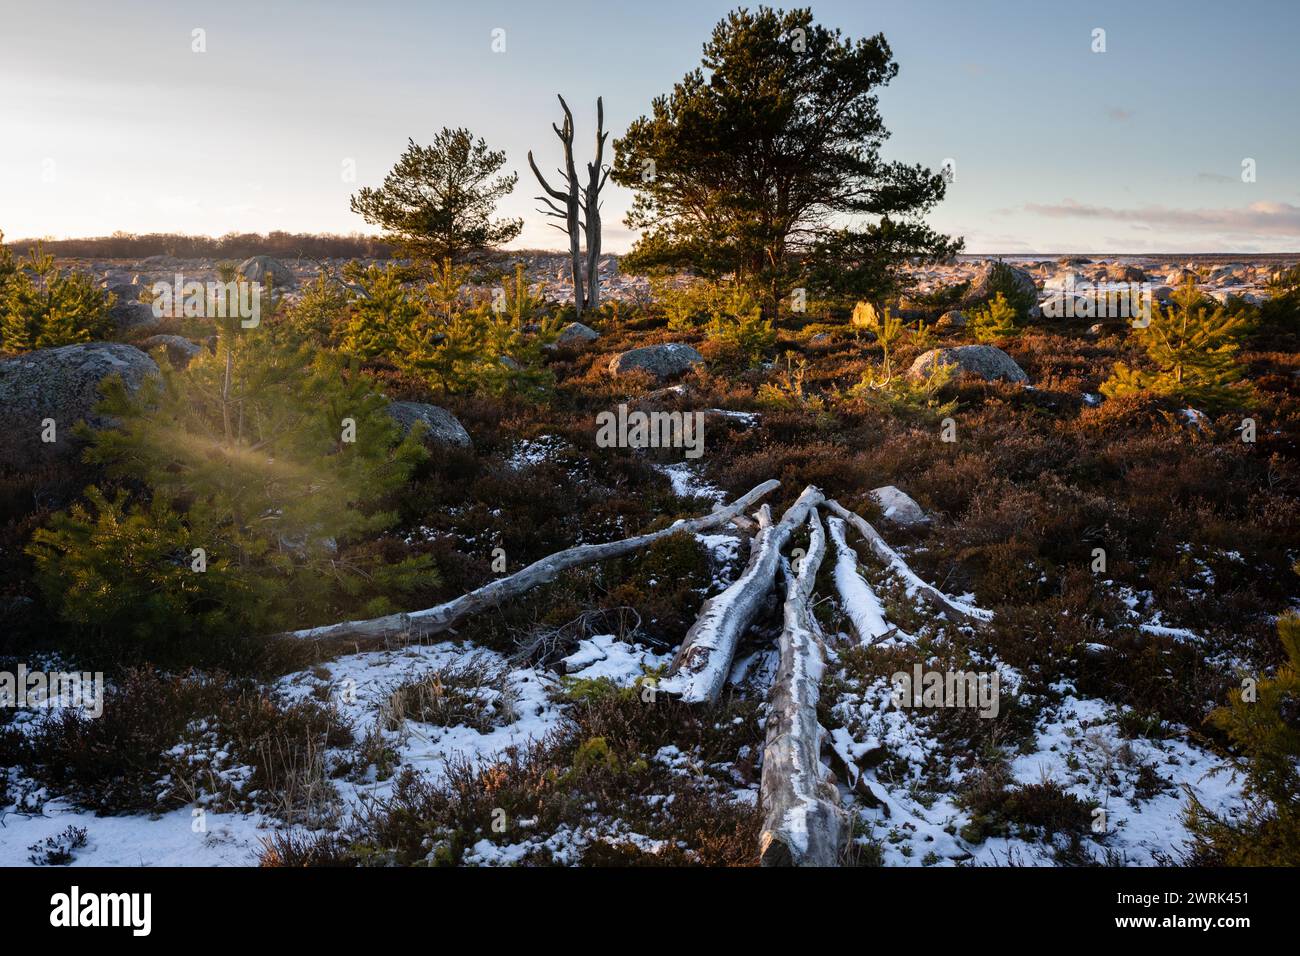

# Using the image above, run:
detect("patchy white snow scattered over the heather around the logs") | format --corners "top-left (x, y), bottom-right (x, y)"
top-left (0, 494), bottom-right (1242, 866)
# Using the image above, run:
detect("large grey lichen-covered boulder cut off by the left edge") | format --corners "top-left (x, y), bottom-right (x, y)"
top-left (0, 342), bottom-right (159, 470)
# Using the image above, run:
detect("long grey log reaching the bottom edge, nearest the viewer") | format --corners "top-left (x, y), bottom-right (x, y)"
top-left (758, 510), bottom-right (846, 866)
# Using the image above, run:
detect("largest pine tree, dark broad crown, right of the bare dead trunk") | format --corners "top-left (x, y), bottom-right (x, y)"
top-left (612, 7), bottom-right (959, 317)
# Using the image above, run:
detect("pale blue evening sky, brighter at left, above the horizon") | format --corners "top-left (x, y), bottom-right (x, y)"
top-left (0, 0), bottom-right (1300, 254)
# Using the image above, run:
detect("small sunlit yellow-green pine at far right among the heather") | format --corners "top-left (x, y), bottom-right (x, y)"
top-left (1101, 281), bottom-right (1252, 408)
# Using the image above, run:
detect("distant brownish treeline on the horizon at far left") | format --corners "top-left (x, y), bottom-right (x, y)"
top-left (5, 232), bottom-right (393, 260)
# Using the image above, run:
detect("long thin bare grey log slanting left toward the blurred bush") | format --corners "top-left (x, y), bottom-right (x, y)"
top-left (281, 479), bottom-right (781, 640)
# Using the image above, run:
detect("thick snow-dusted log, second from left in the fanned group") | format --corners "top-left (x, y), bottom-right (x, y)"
top-left (659, 485), bottom-right (824, 704)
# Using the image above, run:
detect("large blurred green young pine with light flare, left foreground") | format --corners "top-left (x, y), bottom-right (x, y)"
top-left (29, 319), bottom-right (436, 660)
